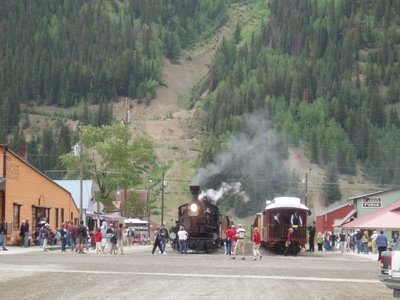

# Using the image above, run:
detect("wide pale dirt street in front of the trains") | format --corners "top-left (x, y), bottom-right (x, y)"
top-left (0, 246), bottom-right (392, 300)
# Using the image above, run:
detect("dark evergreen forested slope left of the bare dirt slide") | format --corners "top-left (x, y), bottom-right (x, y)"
top-left (0, 0), bottom-right (227, 135)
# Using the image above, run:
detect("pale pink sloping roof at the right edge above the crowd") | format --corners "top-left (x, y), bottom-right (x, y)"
top-left (342, 201), bottom-right (400, 229)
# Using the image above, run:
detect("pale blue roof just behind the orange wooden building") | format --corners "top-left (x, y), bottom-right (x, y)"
top-left (54, 180), bottom-right (95, 210)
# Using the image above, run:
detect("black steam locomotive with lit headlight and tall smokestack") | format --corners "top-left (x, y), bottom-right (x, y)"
top-left (169, 185), bottom-right (231, 253)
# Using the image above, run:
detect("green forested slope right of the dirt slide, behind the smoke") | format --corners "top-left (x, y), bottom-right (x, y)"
top-left (198, 0), bottom-right (400, 214)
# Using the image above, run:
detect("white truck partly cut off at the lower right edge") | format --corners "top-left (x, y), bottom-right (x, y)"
top-left (379, 239), bottom-right (400, 298)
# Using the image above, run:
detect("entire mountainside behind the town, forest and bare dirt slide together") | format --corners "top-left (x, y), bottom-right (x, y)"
top-left (0, 0), bottom-right (400, 218)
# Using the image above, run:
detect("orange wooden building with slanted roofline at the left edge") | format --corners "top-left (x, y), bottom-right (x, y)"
top-left (0, 144), bottom-right (79, 244)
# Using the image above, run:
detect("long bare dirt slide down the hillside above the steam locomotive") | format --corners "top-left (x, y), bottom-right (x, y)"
top-left (114, 16), bottom-right (244, 223)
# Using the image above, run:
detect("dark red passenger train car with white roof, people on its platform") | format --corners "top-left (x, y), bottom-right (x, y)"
top-left (252, 197), bottom-right (311, 255)
